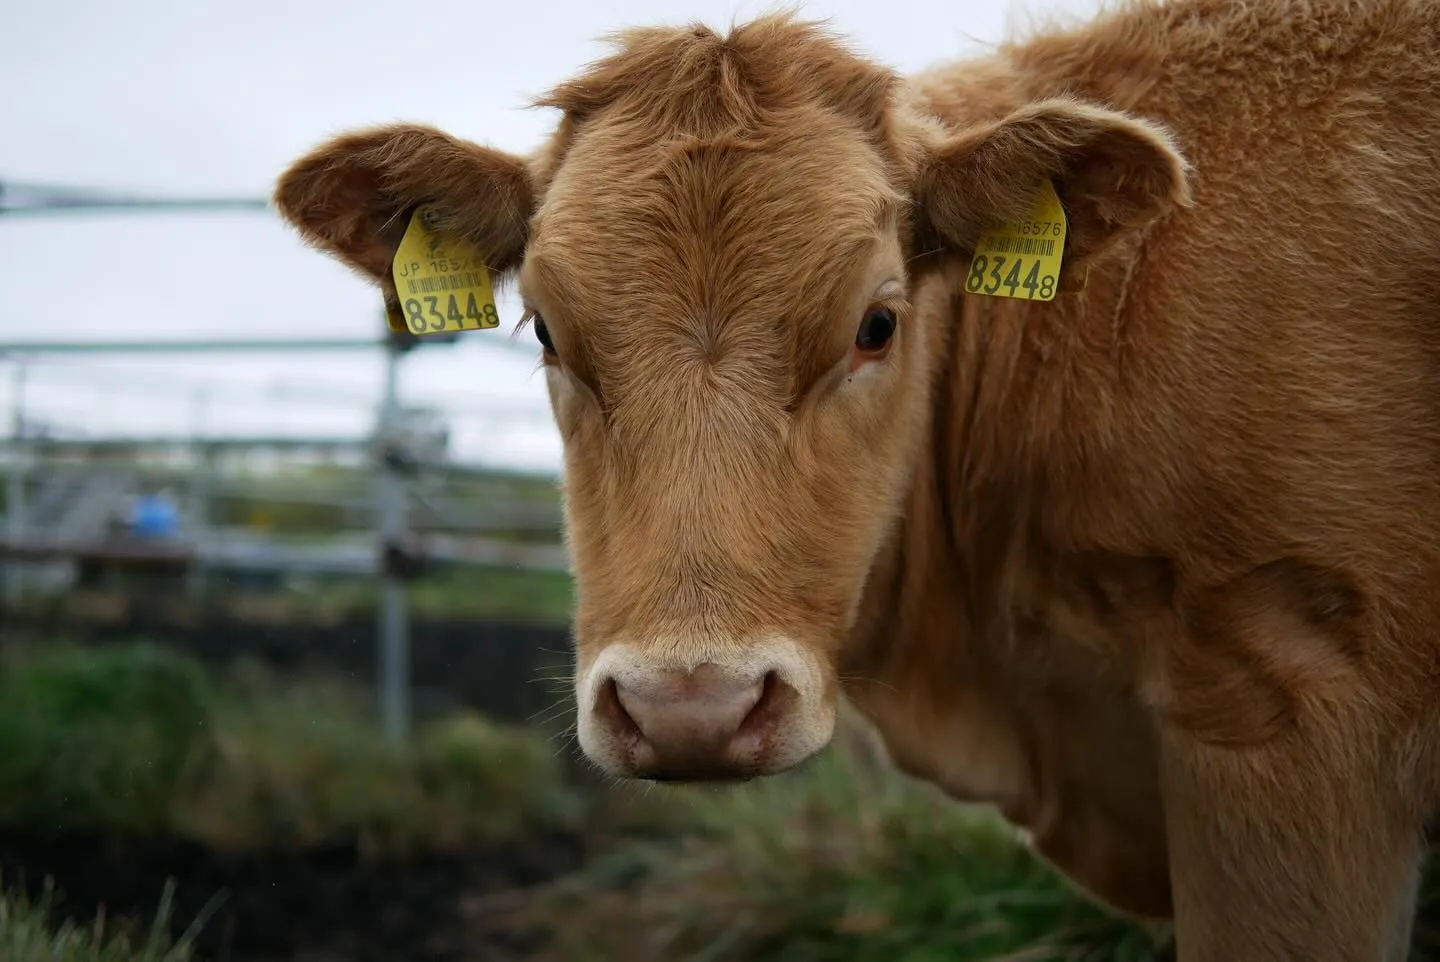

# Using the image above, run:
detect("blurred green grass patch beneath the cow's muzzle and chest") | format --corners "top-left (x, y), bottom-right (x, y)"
top-left (523, 720), bottom-right (1166, 962)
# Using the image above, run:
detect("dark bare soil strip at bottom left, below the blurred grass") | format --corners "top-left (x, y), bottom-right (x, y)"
top-left (0, 831), bottom-right (585, 962)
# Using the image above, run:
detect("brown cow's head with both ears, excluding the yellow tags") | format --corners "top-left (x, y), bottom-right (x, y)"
top-left (276, 17), bottom-right (1184, 779)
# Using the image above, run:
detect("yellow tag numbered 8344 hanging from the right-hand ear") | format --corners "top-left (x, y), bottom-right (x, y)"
top-left (965, 180), bottom-right (1067, 301)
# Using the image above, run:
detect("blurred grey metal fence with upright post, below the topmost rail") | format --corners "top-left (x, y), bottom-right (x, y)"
top-left (0, 326), bottom-right (569, 739)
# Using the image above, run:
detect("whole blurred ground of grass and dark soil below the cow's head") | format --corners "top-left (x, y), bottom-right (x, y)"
top-left (0, 645), bottom-right (1192, 962)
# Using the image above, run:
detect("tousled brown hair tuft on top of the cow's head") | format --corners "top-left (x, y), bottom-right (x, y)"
top-left (536, 12), bottom-right (899, 140)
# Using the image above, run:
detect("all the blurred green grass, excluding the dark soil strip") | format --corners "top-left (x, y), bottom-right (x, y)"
top-left (0, 645), bottom-right (1440, 962)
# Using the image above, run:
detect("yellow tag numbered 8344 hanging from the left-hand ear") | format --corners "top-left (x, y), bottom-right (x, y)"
top-left (390, 209), bottom-right (500, 334)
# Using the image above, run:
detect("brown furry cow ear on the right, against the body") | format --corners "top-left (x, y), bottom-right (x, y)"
top-left (916, 98), bottom-right (1189, 268)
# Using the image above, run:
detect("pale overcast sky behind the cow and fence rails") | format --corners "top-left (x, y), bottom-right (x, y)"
top-left (0, 0), bottom-right (1096, 471)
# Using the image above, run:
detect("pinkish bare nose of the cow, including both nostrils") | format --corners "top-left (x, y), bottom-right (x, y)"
top-left (598, 664), bottom-right (785, 781)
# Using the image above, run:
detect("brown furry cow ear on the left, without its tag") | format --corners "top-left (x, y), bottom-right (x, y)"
top-left (275, 124), bottom-right (534, 287)
